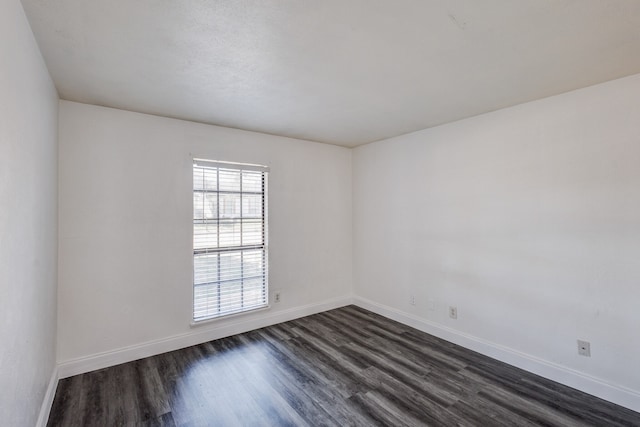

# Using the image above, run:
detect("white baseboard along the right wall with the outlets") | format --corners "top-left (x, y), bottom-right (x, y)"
top-left (354, 297), bottom-right (640, 412)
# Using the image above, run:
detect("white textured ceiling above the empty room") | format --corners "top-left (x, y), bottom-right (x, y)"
top-left (22, 0), bottom-right (640, 146)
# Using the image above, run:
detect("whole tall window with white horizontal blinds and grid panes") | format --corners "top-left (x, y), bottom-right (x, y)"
top-left (193, 159), bottom-right (268, 322)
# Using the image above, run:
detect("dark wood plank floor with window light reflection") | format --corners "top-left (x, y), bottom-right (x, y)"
top-left (48, 306), bottom-right (640, 426)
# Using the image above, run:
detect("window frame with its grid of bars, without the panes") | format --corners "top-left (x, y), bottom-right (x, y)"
top-left (190, 158), bottom-right (271, 326)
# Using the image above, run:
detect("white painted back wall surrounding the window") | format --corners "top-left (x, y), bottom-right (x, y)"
top-left (58, 101), bottom-right (352, 363)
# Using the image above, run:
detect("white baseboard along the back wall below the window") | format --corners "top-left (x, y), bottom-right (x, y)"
top-left (58, 295), bottom-right (353, 378)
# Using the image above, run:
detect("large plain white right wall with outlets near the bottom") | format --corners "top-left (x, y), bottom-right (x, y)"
top-left (353, 75), bottom-right (640, 410)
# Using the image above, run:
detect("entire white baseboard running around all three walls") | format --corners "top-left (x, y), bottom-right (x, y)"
top-left (53, 296), bottom-right (640, 414)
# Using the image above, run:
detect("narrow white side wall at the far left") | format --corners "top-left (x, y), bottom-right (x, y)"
top-left (0, 0), bottom-right (58, 426)
